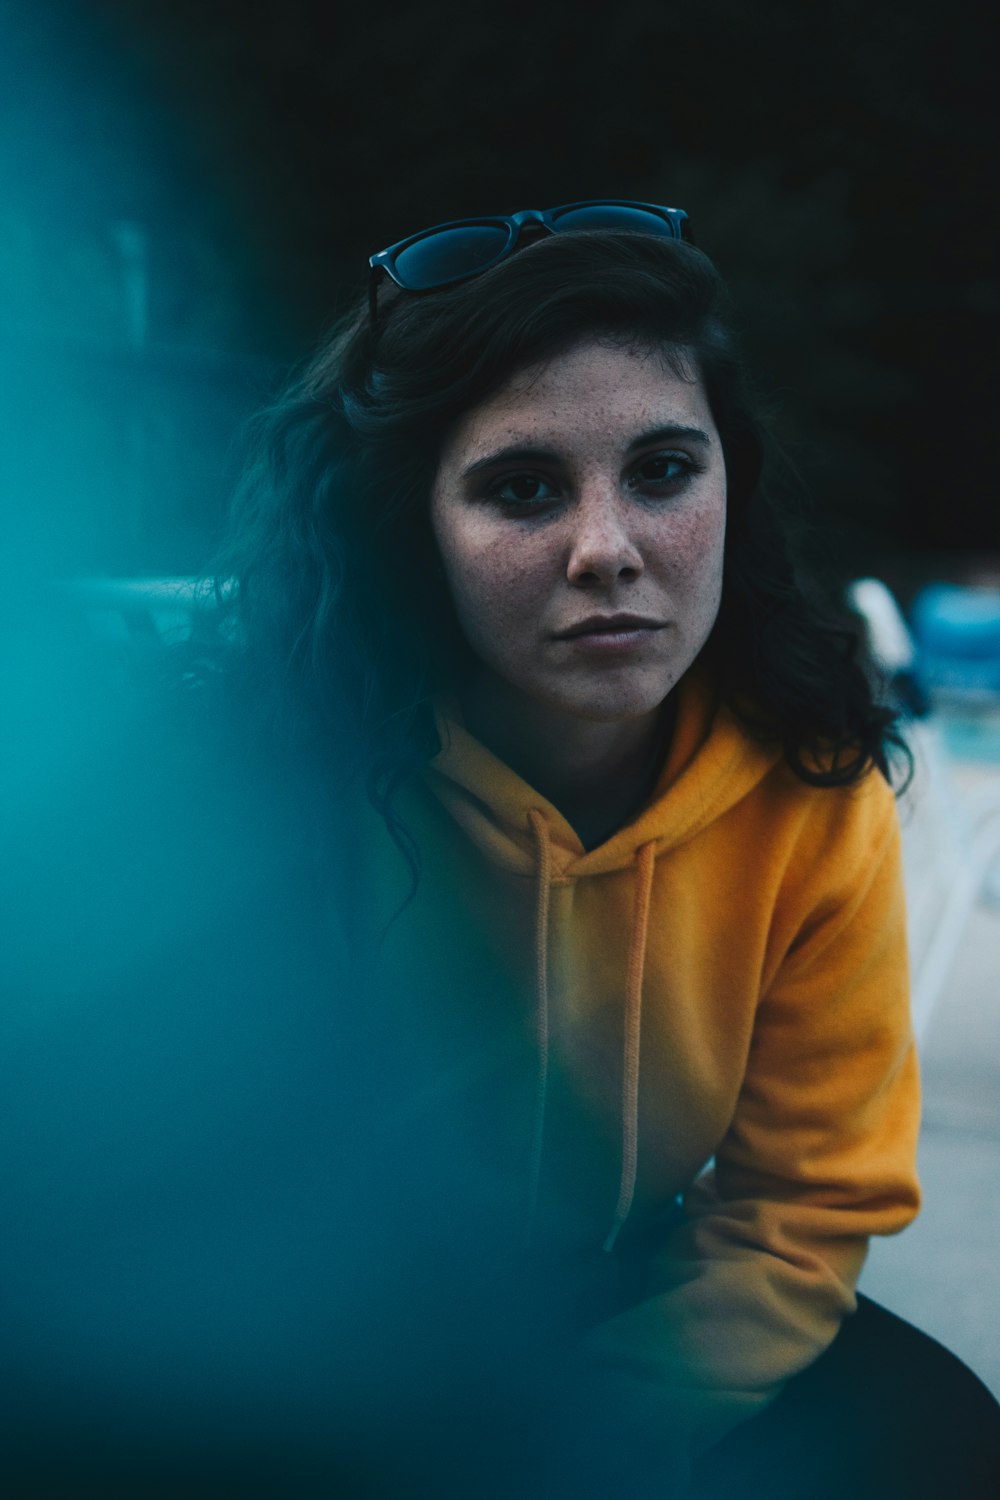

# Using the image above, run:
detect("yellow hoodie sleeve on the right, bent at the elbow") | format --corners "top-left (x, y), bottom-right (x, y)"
top-left (588, 776), bottom-right (919, 1454)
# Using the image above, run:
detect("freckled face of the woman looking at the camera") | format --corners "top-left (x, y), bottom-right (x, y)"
top-left (432, 339), bottom-right (726, 738)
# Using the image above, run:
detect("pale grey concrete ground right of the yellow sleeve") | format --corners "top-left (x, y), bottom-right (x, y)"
top-left (861, 741), bottom-right (1000, 1397)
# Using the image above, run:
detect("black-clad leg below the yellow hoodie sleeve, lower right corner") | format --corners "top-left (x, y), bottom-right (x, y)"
top-left (691, 1296), bottom-right (1000, 1500)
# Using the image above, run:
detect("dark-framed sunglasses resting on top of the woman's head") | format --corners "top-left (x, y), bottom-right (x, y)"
top-left (369, 198), bottom-right (693, 327)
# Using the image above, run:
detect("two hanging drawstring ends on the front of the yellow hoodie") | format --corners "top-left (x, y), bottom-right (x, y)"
top-left (526, 807), bottom-right (657, 1251)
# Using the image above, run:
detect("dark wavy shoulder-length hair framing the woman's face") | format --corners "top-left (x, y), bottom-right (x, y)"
top-left (200, 231), bottom-right (897, 842)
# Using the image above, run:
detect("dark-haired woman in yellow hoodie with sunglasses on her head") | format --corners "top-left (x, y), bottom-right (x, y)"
top-left (193, 204), bottom-right (996, 1494)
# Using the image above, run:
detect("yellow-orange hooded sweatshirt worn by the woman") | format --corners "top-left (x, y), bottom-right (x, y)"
top-left (358, 675), bottom-right (919, 1451)
